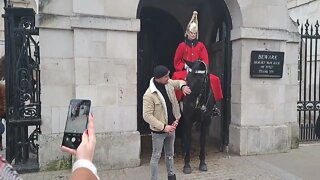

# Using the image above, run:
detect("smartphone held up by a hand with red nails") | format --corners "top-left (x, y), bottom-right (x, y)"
top-left (62, 99), bottom-right (91, 149)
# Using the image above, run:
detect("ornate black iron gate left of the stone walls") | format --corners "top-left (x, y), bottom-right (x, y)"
top-left (3, 1), bottom-right (41, 172)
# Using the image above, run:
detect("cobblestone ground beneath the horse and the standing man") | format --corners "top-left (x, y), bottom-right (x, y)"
top-left (22, 153), bottom-right (301, 180)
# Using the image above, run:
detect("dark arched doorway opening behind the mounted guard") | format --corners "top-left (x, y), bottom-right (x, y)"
top-left (137, 0), bottom-right (231, 153)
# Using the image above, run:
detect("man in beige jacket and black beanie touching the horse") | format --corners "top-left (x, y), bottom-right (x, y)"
top-left (143, 65), bottom-right (191, 180)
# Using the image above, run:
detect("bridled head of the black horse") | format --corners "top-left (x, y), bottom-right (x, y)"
top-left (186, 60), bottom-right (209, 93)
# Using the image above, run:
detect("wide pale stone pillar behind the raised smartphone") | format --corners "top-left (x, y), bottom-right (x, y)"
top-left (37, 0), bottom-right (140, 169)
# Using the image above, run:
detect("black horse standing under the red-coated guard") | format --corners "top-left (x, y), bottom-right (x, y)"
top-left (182, 60), bottom-right (219, 174)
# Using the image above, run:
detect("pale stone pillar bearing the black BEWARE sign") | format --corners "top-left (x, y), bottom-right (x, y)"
top-left (226, 0), bottom-right (299, 155)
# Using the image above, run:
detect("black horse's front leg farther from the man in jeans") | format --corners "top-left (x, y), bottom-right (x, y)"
top-left (199, 117), bottom-right (210, 171)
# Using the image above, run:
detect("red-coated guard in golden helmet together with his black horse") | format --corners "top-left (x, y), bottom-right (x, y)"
top-left (172, 11), bottom-right (223, 174)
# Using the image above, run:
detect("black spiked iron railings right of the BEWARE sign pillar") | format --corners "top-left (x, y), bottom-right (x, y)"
top-left (297, 20), bottom-right (320, 141)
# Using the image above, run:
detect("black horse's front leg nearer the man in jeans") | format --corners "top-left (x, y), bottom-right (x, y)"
top-left (183, 117), bottom-right (192, 174)
